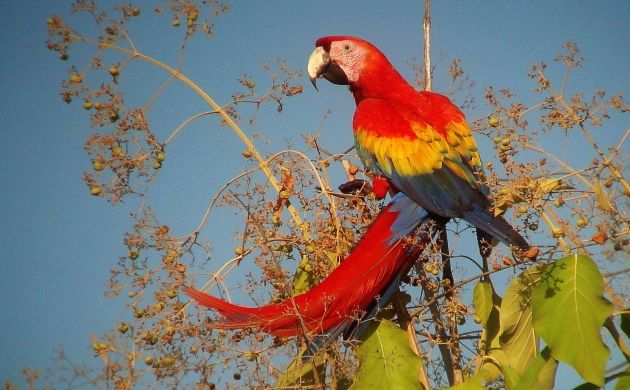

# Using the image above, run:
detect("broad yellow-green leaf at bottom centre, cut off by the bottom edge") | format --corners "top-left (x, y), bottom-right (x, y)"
top-left (350, 320), bottom-right (422, 390)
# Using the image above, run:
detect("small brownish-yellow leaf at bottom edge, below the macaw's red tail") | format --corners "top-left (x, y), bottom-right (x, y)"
top-left (274, 348), bottom-right (326, 389)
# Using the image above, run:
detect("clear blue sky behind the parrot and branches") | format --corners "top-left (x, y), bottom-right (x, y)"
top-left (0, 0), bottom-right (630, 387)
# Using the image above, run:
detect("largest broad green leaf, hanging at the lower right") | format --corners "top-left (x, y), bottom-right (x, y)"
top-left (531, 254), bottom-right (613, 386)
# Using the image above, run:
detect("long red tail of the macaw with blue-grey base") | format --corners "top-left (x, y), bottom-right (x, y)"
top-left (183, 194), bottom-right (431, 337)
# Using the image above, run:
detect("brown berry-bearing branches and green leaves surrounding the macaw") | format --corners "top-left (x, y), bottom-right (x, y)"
top-left (5, 0), bottom-right (630, 389)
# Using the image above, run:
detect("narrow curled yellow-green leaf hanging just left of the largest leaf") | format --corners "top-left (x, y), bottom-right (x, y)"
top-left (499, 265), bottom-right (544, 375)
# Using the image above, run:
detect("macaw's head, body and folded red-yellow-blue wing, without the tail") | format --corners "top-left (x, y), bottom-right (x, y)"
top-left (308, 36), bottom-right (529, 250)
